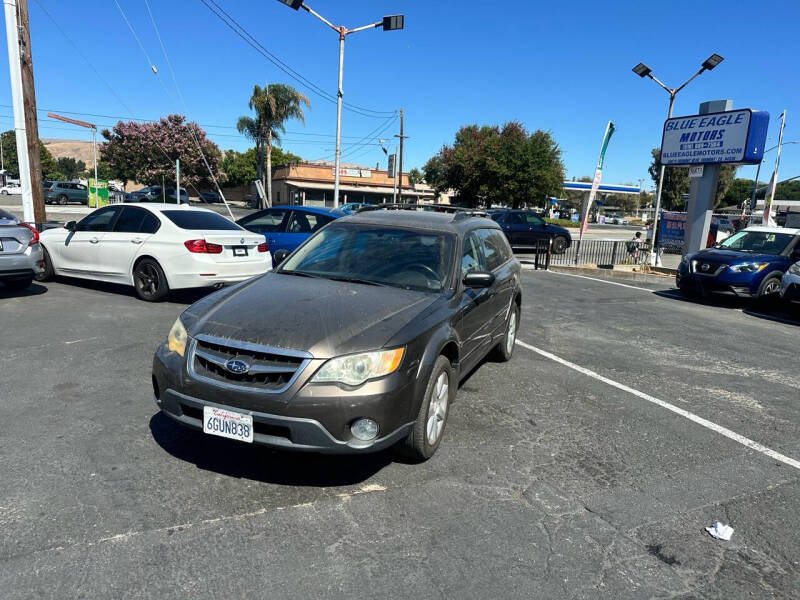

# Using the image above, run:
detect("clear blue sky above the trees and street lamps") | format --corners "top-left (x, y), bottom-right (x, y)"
top-left (0, 0), bottom-right (800, 187)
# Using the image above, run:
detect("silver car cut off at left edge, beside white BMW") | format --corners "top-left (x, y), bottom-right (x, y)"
top-left (0, 209), bottom-right (44, 290)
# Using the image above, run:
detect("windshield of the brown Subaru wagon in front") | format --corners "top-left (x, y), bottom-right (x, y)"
top-left (278, 223), bottom-right (455, 292)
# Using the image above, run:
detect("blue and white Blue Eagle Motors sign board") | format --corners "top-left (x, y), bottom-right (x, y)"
top-left (661, 108), bottom-right (769, 165)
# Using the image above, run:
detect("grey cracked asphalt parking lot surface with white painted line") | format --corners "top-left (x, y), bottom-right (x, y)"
top-left (0, 271), bottom-right (800, 599)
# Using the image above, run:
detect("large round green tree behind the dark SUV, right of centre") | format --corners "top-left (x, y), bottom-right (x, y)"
top-left (424, 121), bottom-right (564, 208)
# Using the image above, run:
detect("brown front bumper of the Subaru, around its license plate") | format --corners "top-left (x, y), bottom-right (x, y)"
top-left (153, 345), bottom-right (419, 454)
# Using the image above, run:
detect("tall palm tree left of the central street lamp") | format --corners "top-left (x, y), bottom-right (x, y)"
top-left (236, 83), bottom-right (311, 206)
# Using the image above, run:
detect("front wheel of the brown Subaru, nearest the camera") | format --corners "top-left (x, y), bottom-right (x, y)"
top-left (398, 356), bottom-right (458, 462)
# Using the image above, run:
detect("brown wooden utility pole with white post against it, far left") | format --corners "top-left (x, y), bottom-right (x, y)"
top-left (3, 0), bottom-right (47, 222)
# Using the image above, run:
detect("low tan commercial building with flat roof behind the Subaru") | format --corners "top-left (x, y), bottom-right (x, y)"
top-left (272, 162), bottom-right (435, 206)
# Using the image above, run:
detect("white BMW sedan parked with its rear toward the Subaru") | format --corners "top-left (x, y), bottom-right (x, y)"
top-left (38, 203), bottom-right (272, 302)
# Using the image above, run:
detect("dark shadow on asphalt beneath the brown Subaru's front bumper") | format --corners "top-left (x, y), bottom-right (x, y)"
top-left (150, 412), bottom-right (394, 487)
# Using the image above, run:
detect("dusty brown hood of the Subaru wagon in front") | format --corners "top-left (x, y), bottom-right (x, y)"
top-left (182, 272), bottom-right (440, 358)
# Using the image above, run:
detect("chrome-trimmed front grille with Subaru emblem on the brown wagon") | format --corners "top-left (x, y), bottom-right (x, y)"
top-left (189, 335), bottom-right (311, 393)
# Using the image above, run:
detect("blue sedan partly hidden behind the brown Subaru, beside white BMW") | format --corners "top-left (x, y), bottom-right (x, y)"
top-left (236, 206), bottom-right (347, 257)
